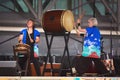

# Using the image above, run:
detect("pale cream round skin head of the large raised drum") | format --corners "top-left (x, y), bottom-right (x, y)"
top-left (61, 10), bottom-right (74, 32)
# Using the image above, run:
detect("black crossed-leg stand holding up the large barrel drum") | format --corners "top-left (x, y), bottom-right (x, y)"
top-left (42, 32), bottom-right (72, 76)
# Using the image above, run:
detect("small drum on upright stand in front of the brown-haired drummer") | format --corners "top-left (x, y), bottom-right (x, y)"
top-left (13, 44), bottom-right (30, 76)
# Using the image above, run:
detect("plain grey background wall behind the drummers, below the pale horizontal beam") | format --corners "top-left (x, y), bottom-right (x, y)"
top-left (0, 32), bottom-right (120, 56)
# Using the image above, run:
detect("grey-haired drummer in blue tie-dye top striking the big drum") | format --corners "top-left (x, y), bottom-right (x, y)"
top-left (76, 18), bottom-right (108, 75)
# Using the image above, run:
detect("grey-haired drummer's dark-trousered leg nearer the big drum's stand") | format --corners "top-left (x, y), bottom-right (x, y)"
top-left (75, 56), bottom-right (92, 75)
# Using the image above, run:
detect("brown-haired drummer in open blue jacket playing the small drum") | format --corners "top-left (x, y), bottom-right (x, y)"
top-left (18, 19), bottom-right (40, 76)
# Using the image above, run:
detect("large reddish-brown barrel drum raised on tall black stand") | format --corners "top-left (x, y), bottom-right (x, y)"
top-left (42, 10), bottom-right (74, 33)
